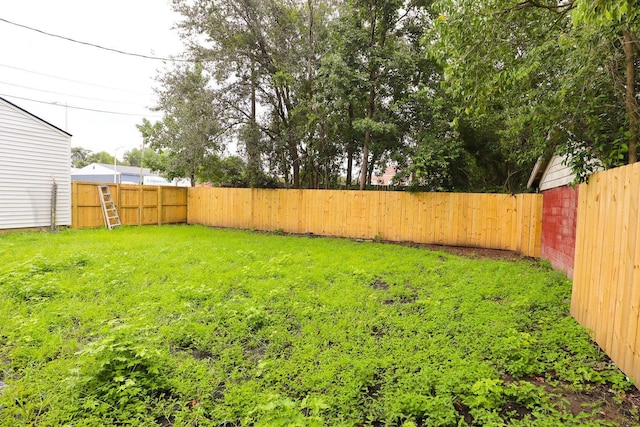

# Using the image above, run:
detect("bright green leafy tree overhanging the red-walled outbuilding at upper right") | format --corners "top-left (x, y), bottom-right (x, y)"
top-left (433, 0), bottom-right (637, 179)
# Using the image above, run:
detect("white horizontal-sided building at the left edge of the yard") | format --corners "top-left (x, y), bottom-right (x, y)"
top-left (0, 97), bottom-right (71, 230)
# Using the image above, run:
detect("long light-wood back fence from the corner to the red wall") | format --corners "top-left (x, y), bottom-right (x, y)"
top-left (187, 188), bottom-right (542, 257)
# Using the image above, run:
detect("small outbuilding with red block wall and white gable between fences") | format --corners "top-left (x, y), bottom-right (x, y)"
top-left (527, 156), bottom-right (578, 278)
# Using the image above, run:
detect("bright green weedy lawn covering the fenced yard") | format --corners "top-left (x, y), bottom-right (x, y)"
top-left (0, 226), bottom-right (637, 427)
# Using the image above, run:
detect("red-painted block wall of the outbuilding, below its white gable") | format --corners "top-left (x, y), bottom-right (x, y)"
top-left (540, 185), bottom-right (578, 278)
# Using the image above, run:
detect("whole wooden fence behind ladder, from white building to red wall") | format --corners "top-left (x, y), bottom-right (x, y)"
top-left (72, 186), bottom-right (542, 256)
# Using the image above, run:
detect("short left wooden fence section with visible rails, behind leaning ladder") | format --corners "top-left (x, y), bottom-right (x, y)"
top-left (71, 181), bottom-right (188, 228)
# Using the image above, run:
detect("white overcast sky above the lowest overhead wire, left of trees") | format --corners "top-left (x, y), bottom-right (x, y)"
top-left (0, 0), bottom-right (183, 159)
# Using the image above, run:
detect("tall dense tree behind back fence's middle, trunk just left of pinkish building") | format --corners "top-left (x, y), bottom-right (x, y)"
top-left (325, 0), bottom-right (424, 189)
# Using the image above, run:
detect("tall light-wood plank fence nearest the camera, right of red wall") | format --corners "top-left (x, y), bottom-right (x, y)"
top-left (571, 163), bottom-right (640, 384)
